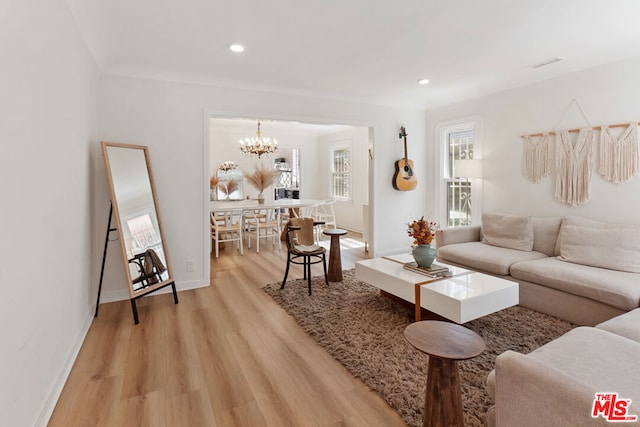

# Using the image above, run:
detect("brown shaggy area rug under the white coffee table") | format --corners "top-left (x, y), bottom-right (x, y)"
top-left (264, 270), bottom-right (575, 427)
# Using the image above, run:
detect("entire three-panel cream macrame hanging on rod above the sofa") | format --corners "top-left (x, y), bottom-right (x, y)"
top-left (522, 98), bottom-right (640, 206)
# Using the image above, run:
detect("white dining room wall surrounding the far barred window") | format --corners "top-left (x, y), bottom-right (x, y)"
top-left (319, 127), bottom-right (369, 232)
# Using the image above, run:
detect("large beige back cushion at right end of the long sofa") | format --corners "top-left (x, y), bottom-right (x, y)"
top-left (559, 225), bottom-right (640, 273)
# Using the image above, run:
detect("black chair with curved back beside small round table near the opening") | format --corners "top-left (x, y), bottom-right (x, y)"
top-left (280, 218), bottom-right (329, 295)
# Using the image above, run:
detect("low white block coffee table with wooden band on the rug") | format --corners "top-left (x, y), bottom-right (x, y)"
top-left (356, 254), bottom-right (519, 323)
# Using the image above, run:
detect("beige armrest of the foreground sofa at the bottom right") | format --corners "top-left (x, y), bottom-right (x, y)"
top-left (495, 351), bottom-right (608, 427)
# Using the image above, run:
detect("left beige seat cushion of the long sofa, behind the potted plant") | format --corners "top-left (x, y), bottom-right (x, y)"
top-left (438, 242), bottom-right (547, 276)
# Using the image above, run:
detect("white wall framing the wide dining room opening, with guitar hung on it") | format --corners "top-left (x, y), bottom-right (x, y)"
top-left (95, 75), bottom-right (427, 298)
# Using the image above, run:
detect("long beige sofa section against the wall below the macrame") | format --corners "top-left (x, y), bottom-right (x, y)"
top-left (436, 213), bottom-right (640, 326)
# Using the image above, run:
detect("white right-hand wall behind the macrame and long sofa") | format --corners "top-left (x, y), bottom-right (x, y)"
top-left (427, 58), bottom-right (640, 223)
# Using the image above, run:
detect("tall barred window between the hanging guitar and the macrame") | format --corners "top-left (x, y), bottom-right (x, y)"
top-left (439, 121), bottom-right (480, 227)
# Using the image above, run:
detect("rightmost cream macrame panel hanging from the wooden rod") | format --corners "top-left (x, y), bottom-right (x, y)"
top-left (598, 123), bottom-right (639, 184)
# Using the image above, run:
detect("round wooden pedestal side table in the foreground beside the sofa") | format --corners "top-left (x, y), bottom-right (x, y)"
top-left (404, 320), bottom-right (485, 427)
